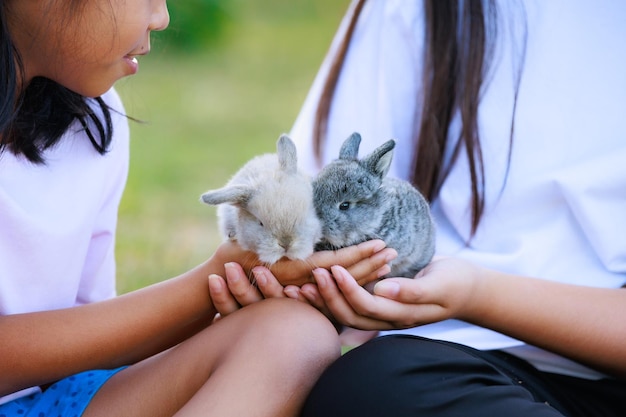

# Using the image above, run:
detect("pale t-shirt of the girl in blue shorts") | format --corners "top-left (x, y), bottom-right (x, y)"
top-left (0, 90), bottom-right (129, 403)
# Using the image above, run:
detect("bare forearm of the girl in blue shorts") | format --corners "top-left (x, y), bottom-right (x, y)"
top-left (0, 260), bottom-right (223, 395)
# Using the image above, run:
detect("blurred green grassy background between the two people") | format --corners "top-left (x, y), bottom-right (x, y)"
top-left (111, 0), bottom-right (349, 293)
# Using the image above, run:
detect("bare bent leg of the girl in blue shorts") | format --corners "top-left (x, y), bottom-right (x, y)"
top-left (84, 299), bottom-right (339, 417)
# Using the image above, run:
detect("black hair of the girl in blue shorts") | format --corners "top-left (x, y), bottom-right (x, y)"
top-left (0, 2), bottom-right (113, 163)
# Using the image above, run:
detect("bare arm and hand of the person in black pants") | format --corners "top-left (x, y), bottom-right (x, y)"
top-left (315, 258), bottom-right (626, 377)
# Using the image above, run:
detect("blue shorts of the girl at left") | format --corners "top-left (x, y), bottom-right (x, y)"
top-left (0, 367), bottom-right (124, 417)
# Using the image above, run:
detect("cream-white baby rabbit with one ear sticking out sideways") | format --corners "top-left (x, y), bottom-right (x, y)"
top-left (201, 134), bottom-right (321, 264)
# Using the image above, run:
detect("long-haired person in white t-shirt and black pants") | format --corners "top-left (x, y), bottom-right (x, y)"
top-left (210, 0), bottom-right (626, 417)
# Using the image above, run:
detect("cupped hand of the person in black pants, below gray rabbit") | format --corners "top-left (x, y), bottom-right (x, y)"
top-left (310, 258), bottom-right (481, 330)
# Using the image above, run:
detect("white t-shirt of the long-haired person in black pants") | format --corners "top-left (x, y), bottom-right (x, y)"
top-left (291, 0), bottom-right (626, 377)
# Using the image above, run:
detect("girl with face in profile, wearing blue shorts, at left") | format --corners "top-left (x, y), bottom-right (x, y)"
top-left (0, 0), bottom-right (386, 417)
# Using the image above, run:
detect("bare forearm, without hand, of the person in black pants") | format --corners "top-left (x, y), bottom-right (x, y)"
top-left (462, 271), bottom-right (626, 377)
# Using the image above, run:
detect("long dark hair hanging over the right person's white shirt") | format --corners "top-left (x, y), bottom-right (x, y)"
top-left (313, 0), bottom-right (525, 234)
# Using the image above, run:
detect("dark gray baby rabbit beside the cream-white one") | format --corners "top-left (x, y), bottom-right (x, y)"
top-left (313, 133), bottom-right (435, 277)
